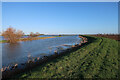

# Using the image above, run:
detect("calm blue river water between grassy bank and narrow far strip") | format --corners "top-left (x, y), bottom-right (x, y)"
top-left (0, 36), bottom-right (81, 67)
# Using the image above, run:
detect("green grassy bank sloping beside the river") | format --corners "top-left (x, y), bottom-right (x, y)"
top-left (11, 36), bottom-right (120, 78)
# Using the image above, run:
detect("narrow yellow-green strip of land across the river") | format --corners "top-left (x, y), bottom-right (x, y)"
top-left (0, 36), bottom-right (61, 43)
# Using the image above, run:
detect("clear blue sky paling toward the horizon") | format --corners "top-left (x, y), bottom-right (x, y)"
top-left (2, 2), bottom-right (118, 34)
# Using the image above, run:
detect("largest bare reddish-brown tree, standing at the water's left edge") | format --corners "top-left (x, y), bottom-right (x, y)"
top-left (2, 27), bottom-right (24, 43)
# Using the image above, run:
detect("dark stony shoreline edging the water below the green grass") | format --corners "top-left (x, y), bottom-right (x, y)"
top-left (1, 36), bottom-right (87, 78)
